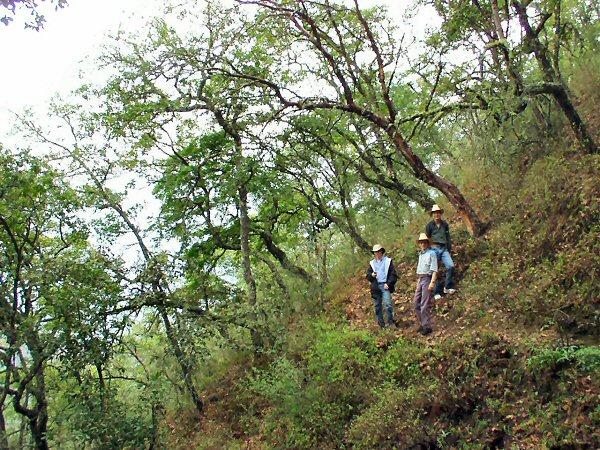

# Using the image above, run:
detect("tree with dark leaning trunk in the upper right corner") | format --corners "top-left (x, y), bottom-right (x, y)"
top-left (426, 0), bottom-right (598, 153)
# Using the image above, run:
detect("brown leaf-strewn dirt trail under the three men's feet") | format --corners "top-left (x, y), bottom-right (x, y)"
top-left (338, 263), bottom-right (561, 352)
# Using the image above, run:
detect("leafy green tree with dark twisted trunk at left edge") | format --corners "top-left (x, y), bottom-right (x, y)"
top-left (0, 149), bottom-right (122, 449)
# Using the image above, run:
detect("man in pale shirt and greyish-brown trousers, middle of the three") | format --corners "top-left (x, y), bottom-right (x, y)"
top-left (415, 233), bottom-right (438, 336)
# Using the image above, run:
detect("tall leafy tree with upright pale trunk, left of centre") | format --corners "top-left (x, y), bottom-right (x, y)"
top-left (97, 5), bottom-right (324, 347)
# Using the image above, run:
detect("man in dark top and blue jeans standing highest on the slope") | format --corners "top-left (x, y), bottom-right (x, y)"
top-left (425, 205), bottom-right (456, 300)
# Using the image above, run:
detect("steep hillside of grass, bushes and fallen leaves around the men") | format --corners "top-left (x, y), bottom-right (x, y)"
top-left (162, 150), bottom-right (600, 449)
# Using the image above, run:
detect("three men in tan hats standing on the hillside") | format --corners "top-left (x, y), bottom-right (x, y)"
top-left (367, 205), bottom-right (456, 335)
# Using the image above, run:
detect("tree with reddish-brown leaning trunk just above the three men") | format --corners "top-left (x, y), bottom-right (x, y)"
top-left (223, 0), bottom-right (487, 236)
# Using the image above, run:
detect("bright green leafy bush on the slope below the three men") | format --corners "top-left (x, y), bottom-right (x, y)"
top-left (247, 322), bottom-right (378, 448)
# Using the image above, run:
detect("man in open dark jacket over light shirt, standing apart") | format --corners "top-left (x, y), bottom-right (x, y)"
top-left (367, 244), bottom-right (398, 328)
